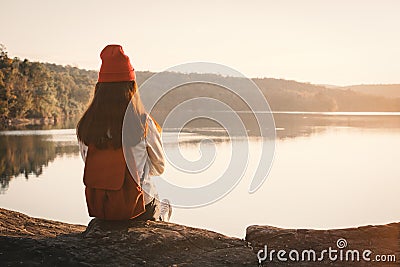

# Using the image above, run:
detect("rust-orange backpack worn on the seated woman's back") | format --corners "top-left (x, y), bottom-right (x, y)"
top-left (83, 145), bottom-right (145, 220)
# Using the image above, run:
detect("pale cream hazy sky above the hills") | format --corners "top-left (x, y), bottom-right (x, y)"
top-left (0, 0), bottom-right (400, 85)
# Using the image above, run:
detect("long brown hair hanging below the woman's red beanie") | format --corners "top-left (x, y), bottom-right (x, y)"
top-left (77, 81), bottom-right (146, 149)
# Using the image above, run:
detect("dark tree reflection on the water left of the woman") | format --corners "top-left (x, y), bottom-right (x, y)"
top-left (0, 131), bottom-right (79, 193)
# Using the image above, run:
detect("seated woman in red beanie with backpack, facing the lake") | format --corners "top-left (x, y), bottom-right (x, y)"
top-left (77, 45), bottom-right (171, 220)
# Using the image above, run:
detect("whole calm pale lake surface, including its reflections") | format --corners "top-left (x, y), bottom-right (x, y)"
top-left (0, 113), bottom-right (400, 237)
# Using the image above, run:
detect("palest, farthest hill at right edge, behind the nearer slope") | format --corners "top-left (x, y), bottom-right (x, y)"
top-left (338, 84), bottom-right (400, 98)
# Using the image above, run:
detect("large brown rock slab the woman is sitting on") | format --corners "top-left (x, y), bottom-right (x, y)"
top-left (0, 209), bottom-right (257, 266)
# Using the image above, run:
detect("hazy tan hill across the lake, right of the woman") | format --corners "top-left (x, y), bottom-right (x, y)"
top-left (138, 72), bottom-right (400, 112)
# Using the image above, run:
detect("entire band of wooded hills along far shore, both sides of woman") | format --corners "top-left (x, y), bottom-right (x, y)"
top-left (0, 45), bottom-right (400, 126)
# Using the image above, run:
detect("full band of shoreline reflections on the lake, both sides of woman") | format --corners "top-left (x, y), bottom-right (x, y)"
top-left (0, 112), bottom-right (400, 193)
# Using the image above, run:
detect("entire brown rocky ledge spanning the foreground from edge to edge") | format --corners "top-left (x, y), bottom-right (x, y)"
top-left (0, 208), bottom-right (400, 266)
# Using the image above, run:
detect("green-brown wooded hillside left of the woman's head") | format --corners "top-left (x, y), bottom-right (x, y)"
top-left (0, 47), bottom-right (97, 119)
